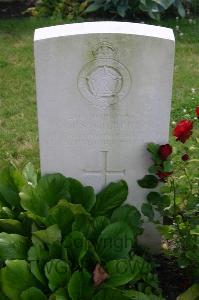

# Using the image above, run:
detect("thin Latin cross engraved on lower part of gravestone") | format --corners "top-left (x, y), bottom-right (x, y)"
top-left (83, 151), bottom-right (126, 185)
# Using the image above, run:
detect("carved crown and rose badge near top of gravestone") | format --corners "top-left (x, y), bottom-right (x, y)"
top-left (78, 42), bottom-right (131, 108)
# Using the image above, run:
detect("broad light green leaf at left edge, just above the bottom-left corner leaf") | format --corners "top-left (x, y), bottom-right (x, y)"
top-left (0, 232), bottom-right (29, 260)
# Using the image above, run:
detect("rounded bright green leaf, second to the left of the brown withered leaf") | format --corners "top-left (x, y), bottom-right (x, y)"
top-left (45, 259), bottom-right (71, 291)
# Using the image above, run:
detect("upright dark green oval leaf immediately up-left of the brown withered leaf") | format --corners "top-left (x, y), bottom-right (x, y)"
top-left (63, 231), bottom-right (88, 266)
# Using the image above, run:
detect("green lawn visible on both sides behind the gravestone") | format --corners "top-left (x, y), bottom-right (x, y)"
top-left (0, 18), bottom-right (199, 167)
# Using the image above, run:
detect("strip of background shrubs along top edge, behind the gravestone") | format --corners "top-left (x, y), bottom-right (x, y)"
top-left (32, 0), bottom-right (194, 19)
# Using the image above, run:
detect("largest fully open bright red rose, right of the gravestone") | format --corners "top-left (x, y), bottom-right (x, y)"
top-left (173, 120), bottom-right (193, 143)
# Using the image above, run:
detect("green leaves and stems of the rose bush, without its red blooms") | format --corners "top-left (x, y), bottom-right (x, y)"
top-left (138, 140), bottom-right (199, 280)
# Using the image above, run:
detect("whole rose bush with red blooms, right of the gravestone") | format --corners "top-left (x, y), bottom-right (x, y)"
top-left (138, 108), bottom-right (199, 280)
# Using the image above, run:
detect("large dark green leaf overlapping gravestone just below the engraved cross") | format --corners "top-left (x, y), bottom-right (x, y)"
top-left (92, 180), bottom-right (128, 216)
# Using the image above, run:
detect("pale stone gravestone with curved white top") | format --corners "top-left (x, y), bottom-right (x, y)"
top-left (34, 22), bottom-right (174, 251)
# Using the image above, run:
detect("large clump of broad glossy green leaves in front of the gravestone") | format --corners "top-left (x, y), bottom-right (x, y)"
top-left (0, 164), bottom-right (160, 300)
